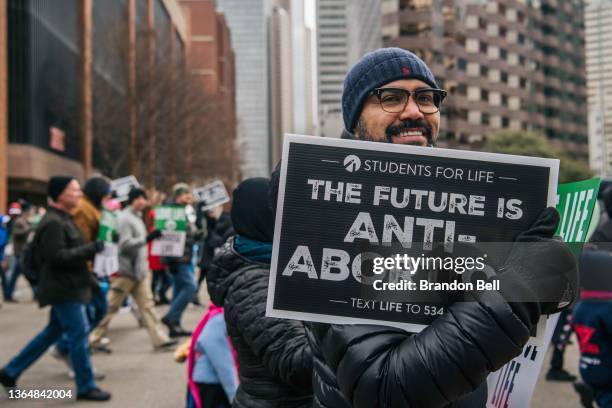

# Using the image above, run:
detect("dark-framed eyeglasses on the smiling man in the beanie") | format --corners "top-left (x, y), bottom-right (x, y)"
top-left (370, 88), bottom-right (446, 114)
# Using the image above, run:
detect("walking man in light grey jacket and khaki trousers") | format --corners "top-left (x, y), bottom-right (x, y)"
top-left (89, 188), bottom-right (176, 350)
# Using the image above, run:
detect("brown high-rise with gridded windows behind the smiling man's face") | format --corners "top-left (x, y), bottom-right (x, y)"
top-left (383, 0), bottom-right (587, 151)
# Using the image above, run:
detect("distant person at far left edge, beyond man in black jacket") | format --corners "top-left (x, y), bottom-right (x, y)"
top-left (4, 202), bottom-right (36, 302)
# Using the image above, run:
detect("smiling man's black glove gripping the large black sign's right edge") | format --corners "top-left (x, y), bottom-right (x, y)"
top-left (499, 207), bottom-right (577, 324)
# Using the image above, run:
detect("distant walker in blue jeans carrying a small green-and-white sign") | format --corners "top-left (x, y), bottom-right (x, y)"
top-left (161, 183), bottom-right (202, 337)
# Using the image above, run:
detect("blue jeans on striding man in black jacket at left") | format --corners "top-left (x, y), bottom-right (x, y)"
top-left (4, 302), bottom-right (96, 394)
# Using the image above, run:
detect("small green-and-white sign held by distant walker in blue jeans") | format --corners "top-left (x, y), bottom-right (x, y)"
top-left (151, 205), bottom-right (187, 257)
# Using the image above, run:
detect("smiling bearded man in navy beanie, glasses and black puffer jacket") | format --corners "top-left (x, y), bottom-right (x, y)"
top-left (270, 48), bottom-right (576, 408)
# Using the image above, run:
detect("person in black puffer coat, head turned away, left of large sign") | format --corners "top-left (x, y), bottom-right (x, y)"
top-left (206, 178), bottom-right (313, 408)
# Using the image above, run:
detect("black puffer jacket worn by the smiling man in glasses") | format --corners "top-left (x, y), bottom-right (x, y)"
top-left (307, 292), bottom-right (530, 408)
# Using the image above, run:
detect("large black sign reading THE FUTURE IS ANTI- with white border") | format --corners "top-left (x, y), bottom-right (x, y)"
top-left (266, 135), bottom-right (559, 331)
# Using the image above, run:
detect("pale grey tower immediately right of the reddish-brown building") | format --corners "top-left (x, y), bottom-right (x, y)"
top-left (217, 0), bottom-right (271, 178)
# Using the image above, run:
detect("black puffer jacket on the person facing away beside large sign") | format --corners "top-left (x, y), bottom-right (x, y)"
top-left (207, 239), bottom-right (312, 408)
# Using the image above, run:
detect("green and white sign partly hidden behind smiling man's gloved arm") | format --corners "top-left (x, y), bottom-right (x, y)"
top-left (487, 178), bottom-right (601, 408)
